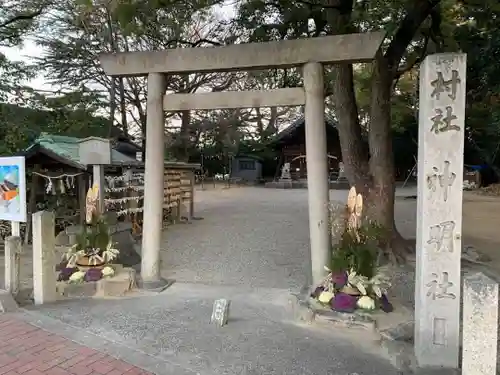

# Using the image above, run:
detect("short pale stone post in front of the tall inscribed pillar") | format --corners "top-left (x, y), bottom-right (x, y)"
top-left (462, 273), bottom-right (498, 375)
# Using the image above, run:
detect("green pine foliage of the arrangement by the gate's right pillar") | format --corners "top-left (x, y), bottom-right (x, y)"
top-left (330, 224), bottom-right (385, 278)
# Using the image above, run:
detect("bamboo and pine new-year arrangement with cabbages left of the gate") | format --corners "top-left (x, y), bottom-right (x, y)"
top-left (59, 184), bottom-right (119, 282)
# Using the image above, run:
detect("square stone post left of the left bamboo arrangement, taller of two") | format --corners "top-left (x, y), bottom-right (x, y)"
top-left (33, 211), bottom-right (57, 305)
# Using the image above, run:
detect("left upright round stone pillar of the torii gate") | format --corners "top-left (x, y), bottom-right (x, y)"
top-left (141, 73), bottom-right (165, 289)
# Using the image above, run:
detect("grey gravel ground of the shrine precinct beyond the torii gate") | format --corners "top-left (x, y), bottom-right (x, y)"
top-left (161, 187), bottom-right (416, 291)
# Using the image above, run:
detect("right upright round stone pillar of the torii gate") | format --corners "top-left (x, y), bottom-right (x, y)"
top-left (304, 62), bottom-right (330, 285)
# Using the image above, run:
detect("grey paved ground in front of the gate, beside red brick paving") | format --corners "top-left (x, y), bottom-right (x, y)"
top-left (25, 283), bottom-right (397, 375)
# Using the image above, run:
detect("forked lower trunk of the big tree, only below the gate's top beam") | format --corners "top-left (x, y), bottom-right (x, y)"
top-left (333, 61), bottom-right (405, 261)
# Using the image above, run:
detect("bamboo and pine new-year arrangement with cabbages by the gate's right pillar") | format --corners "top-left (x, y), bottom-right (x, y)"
top-left (311, 187), bottom-right (393, 313)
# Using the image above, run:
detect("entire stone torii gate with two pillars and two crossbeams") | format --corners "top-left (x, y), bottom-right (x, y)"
top-left (100, 32), bottom-right (384, 289)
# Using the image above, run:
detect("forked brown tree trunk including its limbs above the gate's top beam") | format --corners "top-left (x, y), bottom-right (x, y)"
top-left (319, 0), bottom-right (440, 261)
